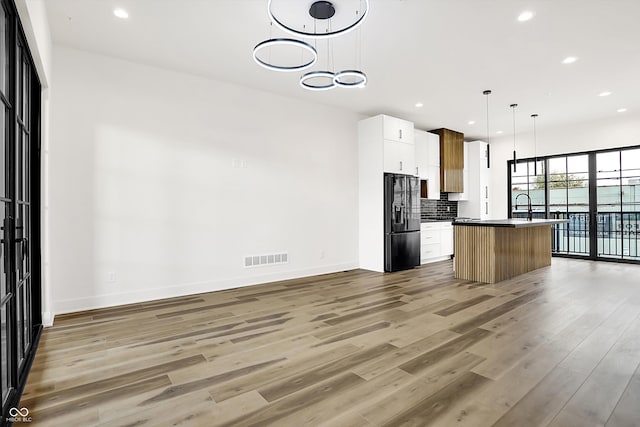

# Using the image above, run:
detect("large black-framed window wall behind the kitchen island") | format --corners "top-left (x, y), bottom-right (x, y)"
top-left (509, 147), bottom-right (640, 262)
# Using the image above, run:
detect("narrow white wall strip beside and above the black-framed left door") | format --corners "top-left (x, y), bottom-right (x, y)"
top-left (16, 0), bottom-right (53, 326)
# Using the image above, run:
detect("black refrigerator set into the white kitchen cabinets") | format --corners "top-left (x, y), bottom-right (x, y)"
top-left (384, 173), bottom-right (420, 271)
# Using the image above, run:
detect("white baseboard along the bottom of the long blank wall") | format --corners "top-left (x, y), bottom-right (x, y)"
top-left (52, 261), bottom-right (358, 318)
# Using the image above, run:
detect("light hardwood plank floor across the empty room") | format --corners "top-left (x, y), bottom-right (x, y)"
top-left (21, 258), bottom-right (640, 427)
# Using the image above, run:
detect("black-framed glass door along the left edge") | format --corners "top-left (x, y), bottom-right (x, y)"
top-left (0, 0), bottom-right (42, 426)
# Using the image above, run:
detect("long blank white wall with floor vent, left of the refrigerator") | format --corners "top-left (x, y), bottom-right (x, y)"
top-left (50, 46), bottom-right (360, 313)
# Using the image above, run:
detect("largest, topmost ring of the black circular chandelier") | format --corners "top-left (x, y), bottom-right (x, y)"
top-left (267, 0), bottom-right (369, 39)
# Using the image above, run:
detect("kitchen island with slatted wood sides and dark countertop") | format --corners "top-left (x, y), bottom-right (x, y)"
top-left (453, 219), bottom-right (568, 283)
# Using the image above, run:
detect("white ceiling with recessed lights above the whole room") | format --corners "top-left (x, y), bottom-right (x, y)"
top-left (46, 0), bottom-right (640, 138)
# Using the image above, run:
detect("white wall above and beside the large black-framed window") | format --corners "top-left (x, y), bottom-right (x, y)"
top-left (491, 113), bottom-right (640, 218)
